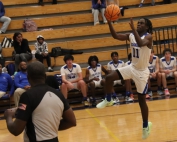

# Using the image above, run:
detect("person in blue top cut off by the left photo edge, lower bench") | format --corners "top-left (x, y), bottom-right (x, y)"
top-left (0, 64), bottom-right (13, 98)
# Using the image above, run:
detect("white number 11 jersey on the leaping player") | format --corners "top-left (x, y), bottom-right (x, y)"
top-left (129, 33), bottom-right (151, 70)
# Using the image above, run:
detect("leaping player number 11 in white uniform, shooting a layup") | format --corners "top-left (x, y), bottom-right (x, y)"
top-left (97, 18), bottom-right (152, 139)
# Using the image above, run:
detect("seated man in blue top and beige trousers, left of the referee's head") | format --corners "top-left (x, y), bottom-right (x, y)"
top-left (14, 62), bottom-right (31, 107)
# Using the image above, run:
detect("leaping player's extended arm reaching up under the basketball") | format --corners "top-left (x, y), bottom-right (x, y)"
top-left (108, 21), bottom-right (129, 40)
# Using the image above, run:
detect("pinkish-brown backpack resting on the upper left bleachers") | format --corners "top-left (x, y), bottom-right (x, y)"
top-left (23, 19), bottom-right (38, 32)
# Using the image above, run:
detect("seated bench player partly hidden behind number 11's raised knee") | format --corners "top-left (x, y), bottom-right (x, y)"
top-left (107, 52), bottom-right (129, 103)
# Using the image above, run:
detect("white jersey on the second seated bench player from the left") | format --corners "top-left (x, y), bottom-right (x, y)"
top-left (87, 64), bottom-right (102, 80)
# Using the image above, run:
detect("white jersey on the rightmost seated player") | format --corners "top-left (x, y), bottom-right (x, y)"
top-left (160, 56), bottom-right (176, 70)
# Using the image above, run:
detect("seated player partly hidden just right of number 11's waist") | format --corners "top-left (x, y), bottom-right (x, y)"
top-left (146, 49), bottom-right (162, 98)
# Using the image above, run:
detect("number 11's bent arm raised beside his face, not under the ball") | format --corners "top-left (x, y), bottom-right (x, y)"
top-left (129, 18), bottom-right (152, 49)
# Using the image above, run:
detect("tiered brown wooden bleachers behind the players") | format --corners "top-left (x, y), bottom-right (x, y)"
top-left (0, 0), bottom-right (177, 107)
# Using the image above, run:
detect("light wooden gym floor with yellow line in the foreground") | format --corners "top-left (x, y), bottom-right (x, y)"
top-left (0, 98), bottom-right (177, 142)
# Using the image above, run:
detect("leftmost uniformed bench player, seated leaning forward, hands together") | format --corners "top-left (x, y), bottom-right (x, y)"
top-left (60, 54), bottom-right (89, 106)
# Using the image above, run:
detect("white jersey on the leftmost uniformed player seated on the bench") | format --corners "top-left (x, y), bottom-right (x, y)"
top-left (60, 63), bottom-right (82, 81)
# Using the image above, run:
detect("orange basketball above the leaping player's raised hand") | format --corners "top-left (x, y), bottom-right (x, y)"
top-left (105, 4), bottom-right (120, 21)
